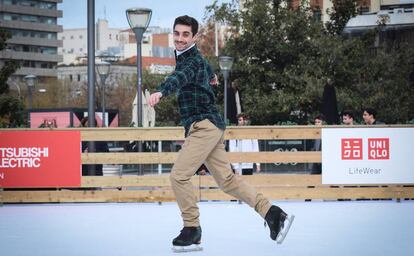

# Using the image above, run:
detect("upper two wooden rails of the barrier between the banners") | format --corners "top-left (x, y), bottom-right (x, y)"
top-left (81, 126), bottom-right (321, 164)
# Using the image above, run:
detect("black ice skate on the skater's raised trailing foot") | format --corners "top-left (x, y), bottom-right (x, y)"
top-left (265, 205), bottom-right (295, 244)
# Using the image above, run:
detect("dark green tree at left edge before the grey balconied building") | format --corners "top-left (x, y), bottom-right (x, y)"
top-left (0, 28), bottom-right (24, 127)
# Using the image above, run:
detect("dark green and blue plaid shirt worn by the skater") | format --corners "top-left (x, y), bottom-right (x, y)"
top-left (157, 46), bottom-right (226, 136)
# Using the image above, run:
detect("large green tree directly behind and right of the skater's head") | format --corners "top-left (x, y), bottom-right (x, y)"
top-left (207, 0), bottom-right (324, 124)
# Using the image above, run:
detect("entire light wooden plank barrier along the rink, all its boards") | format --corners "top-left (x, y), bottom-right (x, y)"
top-left (0, 126), bottom-right (414, 203)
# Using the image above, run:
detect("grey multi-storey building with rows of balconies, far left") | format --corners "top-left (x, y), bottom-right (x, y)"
top-left (0, 0), bottom-right (63, 79)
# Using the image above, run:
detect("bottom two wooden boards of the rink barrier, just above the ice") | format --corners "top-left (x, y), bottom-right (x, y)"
top-left (1, 174), bottom-right (414, 203)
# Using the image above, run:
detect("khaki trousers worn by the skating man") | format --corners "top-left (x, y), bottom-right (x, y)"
top-left (170, 119), bottom-right (271, 227)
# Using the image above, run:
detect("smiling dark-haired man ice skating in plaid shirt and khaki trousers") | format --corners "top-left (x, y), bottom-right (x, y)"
top-left (148, 15), bottom-right (294, 252)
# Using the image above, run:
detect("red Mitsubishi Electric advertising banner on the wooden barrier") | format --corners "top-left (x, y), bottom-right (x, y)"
top-left (0, 131), bottom-right (81, 188)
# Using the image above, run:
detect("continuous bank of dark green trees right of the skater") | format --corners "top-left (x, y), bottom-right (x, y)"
top-left (207, 0), bottom-right (414, 124)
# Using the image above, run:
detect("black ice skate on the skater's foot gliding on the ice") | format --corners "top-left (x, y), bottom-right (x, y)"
top-left (172, 227), bottom-right (203, 252)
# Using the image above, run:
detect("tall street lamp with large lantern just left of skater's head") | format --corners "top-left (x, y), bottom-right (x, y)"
top-left (126, 8), bottom-right (152, 174)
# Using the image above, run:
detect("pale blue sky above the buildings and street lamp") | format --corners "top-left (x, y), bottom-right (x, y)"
top-left (58, 0), bottom-right (230, 29)
